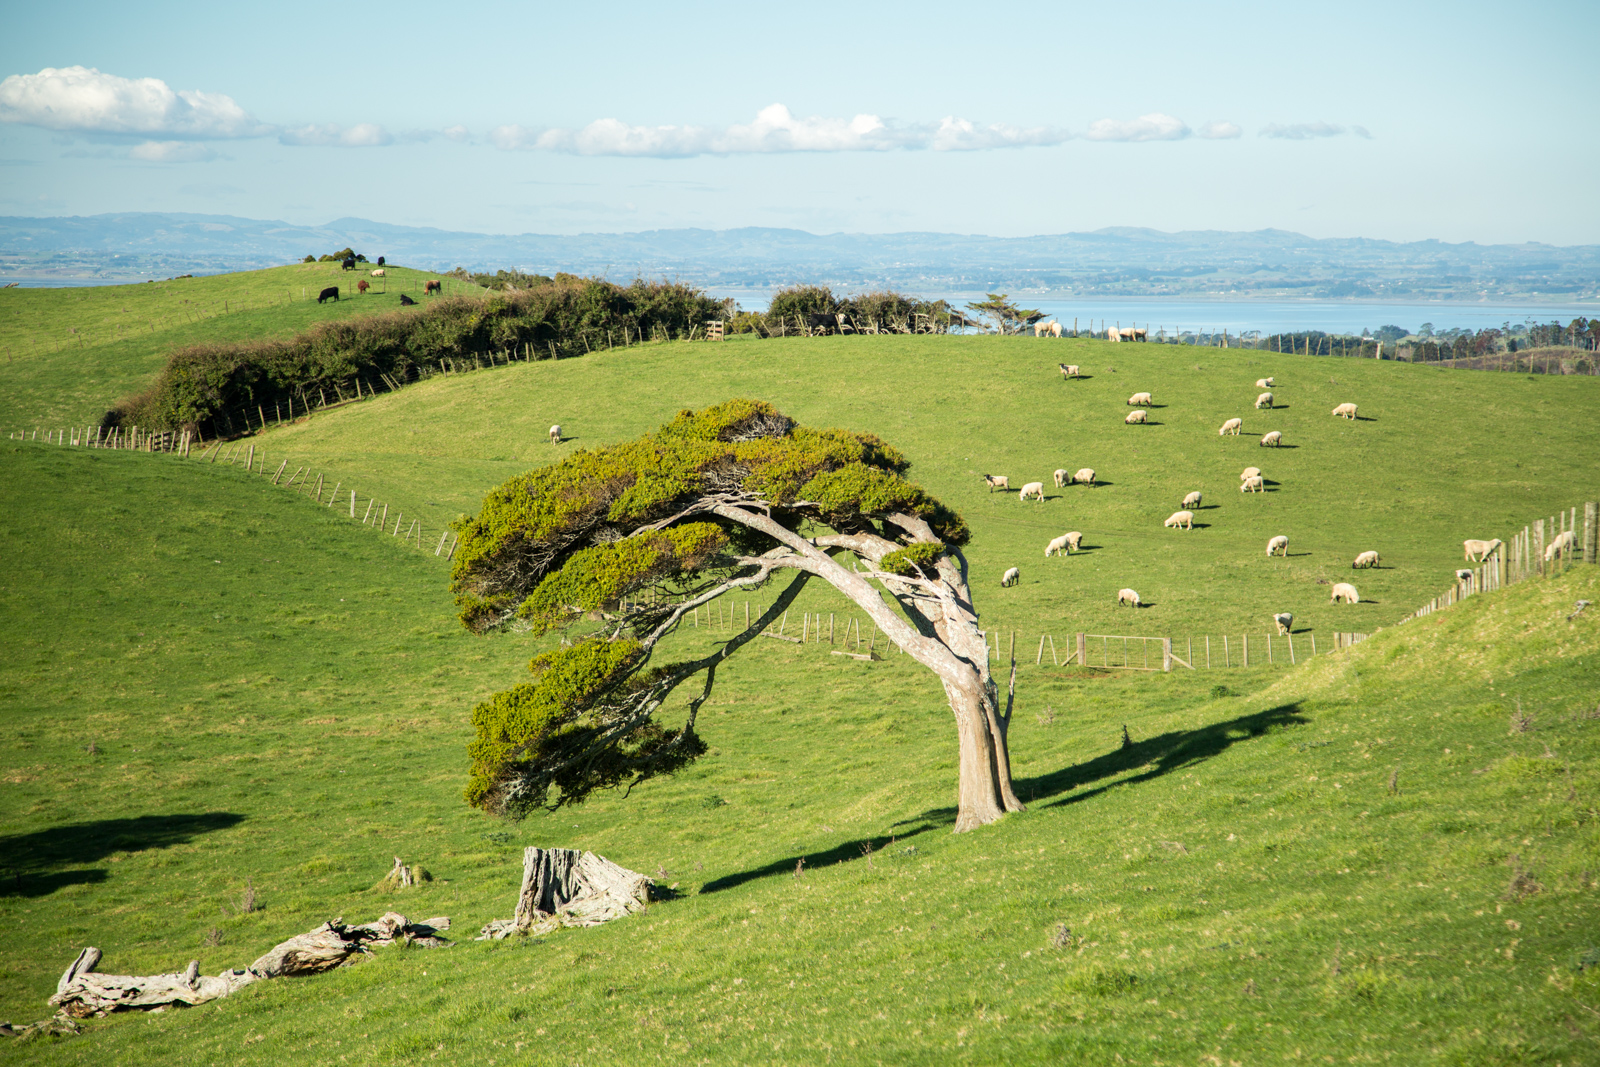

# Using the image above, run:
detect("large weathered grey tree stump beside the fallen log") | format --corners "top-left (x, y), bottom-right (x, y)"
top-left (478, 846), bottom-right (654, 941)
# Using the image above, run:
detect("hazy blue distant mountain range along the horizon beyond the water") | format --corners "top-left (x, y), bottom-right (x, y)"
top-left (0, 213), bottom-right (1600, 301)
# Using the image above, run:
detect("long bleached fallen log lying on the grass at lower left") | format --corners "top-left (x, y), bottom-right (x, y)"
top-left (50, 912), bottom-right (450, 1019)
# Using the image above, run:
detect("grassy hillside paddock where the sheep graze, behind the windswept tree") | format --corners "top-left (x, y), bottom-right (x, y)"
top-left (258, 329), bottom-right (1600, 639)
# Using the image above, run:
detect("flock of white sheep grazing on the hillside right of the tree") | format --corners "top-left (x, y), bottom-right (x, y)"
top-left (982, 371), bottom-right (1382, 635)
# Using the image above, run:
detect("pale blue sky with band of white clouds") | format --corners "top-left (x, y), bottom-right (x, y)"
top-left (0, 0), bottom-right (1600, 245)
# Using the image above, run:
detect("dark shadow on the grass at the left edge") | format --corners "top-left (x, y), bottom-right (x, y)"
top-left (0, 811), bottom-right (245, 897)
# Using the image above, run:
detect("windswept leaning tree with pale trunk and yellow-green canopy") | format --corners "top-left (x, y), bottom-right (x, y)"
top-left (453, 400), bottom-right (1022, 830)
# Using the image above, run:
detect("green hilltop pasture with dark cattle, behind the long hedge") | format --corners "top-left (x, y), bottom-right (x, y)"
top-left (0, 262), bottom-right (472, 434)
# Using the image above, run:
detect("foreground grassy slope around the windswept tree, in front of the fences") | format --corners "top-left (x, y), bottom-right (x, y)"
top-left (0, 441), bottom-right (1600, 1064)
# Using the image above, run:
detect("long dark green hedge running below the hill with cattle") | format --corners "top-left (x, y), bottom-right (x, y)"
top-left (104, 275), bottom-right (725, 437)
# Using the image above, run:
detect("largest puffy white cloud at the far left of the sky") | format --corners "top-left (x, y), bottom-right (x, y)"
top-left (0, 67), bottom-right (272, 138)
